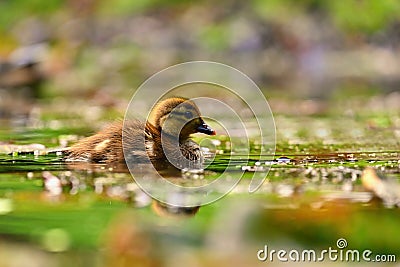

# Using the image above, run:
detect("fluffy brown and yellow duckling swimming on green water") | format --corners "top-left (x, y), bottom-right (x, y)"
top-left (67, 97), bottom-right (215, 169)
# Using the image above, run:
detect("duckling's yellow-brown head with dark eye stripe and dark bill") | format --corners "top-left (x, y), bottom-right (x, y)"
top-left (149, 97), bottom-right (215, 140)
